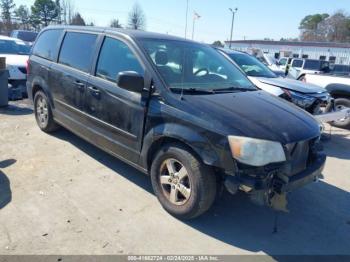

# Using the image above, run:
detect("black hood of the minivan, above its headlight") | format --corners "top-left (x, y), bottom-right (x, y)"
top-left (185, 91), bottom-right (320, 144)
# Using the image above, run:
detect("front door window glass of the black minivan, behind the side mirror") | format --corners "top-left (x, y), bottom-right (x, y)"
top-left (96, 37), bottom-right (144, 81)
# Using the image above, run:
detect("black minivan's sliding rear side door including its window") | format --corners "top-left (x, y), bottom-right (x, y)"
top-left (50, 32), bottom-right (98, 126)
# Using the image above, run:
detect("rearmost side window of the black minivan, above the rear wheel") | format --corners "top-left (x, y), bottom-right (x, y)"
top-left (33, 30), bottom-right (62, 61)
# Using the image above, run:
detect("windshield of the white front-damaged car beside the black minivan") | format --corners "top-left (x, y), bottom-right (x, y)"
top-left (229, 53), bottom-right (277, 78)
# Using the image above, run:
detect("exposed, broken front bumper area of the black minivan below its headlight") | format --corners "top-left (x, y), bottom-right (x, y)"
top-left (225, 138), bottom-right (326, 212)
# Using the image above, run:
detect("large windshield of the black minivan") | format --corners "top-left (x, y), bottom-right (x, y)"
top-left (141, 39), bottom-right (256, 91)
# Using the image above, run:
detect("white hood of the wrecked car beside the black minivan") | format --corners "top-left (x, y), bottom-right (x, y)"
top-left (259, 77), bottom-right (327, 94)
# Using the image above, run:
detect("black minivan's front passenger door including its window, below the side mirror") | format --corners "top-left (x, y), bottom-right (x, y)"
top-left (86, 36), bottom-right (146, 162)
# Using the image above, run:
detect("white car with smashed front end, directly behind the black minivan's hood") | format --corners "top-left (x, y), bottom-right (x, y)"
top-left (219, 49), bottom-right (350, 127)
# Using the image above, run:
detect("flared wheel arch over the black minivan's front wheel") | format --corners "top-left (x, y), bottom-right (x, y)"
top-left (140, 123), bottom-right (227, 172)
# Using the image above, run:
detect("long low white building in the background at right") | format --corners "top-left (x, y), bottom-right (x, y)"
top-left (225, 40), bottom-right (350, 65)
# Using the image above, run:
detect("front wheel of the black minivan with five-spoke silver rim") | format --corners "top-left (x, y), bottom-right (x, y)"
top-left (151, 144), bottom-right (217, 220)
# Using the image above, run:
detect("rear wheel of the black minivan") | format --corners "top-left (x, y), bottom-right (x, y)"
top-left (34, 91), bottom-right (59, 133)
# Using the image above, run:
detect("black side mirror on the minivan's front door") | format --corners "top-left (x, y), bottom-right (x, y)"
top-left (117, 71), bottom-right (145, 93)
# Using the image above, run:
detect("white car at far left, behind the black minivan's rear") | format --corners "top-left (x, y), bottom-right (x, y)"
top-left (0, 36), bottom-right (30, 96)
